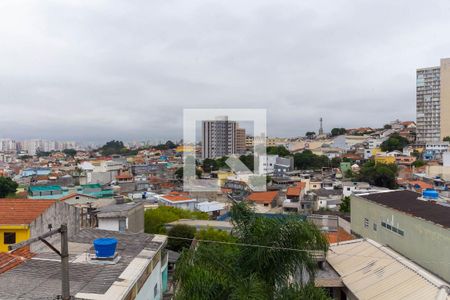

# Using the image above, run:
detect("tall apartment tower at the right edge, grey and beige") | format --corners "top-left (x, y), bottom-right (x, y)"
top-left (416, 58), bottom-right (450, 144)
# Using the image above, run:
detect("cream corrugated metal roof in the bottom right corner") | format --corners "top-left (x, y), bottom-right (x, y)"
top-left (327, 239), bottom-right (450, 300)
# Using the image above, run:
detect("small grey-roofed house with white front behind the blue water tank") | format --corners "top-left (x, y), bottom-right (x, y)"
top-left (96, 202), bottom-right (144, 233)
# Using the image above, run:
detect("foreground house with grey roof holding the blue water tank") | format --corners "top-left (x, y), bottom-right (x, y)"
top-left (0, 229), bottom-right (168, 300)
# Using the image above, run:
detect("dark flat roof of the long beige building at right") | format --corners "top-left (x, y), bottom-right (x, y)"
top-left (359, 191), bottom-right (450, 228)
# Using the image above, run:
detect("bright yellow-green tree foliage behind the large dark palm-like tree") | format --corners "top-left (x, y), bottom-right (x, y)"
top-left (144, 206), bottom-right (208, 234)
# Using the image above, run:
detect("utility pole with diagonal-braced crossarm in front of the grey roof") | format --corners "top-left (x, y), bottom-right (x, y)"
top-left (8, 224), bottom-right (70, 300)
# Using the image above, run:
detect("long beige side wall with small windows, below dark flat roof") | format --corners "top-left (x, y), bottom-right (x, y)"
top-left (351, 196), bottom-right (450, 281)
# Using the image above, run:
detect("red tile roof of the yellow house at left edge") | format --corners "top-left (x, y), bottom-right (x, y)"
top-left (0, 199), bottom-right (56, 225)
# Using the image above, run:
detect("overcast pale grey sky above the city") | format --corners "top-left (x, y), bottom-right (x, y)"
top-left (0, 0), bottom-right (450, 142)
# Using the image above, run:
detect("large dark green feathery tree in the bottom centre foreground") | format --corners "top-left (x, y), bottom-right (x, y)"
top-left (175, 203), bottom-right (328, 300)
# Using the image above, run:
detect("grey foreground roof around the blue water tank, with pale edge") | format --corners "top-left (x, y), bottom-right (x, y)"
top-left (0, 229), bottom-right (167, 299)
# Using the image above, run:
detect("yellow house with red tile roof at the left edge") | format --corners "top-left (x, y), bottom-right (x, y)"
top-left (0, 199), bottom-right (55, 252)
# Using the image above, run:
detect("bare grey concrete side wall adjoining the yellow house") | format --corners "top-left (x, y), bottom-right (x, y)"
top-left (30, 200), bottom-right (81, 251)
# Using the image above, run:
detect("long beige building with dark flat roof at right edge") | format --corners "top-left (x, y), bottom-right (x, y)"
top-left (351, 191), bottom-right (450, 281)
